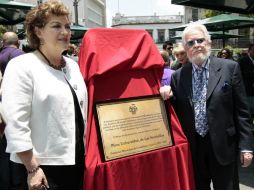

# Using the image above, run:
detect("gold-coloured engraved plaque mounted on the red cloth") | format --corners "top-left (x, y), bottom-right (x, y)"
top-left (95, 96), bottom-right (173, 161)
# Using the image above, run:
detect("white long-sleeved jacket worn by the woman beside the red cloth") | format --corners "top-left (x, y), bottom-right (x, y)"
top-left (2, 53), bottom-right (87, 165)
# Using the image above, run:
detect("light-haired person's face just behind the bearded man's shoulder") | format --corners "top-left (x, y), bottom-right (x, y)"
top-left (171, 42), bottom-right (189, 70)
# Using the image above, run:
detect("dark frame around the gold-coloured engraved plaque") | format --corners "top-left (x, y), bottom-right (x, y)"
top-left (93, 94), bottom-right (175, 162)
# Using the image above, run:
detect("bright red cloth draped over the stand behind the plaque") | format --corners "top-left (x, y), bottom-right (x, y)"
top-left (79, 29), bottom-right (195, 190)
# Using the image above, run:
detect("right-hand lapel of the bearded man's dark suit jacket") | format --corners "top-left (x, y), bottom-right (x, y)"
top-left (206, 57), bottom-right (221, 100)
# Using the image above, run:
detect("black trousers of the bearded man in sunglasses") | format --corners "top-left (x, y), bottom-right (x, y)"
top-left (192, 134), bottom-right (239, 190)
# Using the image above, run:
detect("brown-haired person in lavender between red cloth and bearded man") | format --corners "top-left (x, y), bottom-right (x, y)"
top-left (160, 50), bottom-right (174, 86)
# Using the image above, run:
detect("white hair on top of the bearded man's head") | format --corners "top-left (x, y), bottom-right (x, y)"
top-left (182, 23), bottom-right (211, 45)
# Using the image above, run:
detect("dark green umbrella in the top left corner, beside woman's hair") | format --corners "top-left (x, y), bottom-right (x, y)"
top-left (0, 0), bottom-right (35, 25)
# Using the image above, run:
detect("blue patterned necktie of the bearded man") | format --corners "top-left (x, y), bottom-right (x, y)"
top-left (193, 68), bottom-right (208, 137)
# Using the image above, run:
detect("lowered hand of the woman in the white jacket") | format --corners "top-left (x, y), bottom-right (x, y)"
top-left (27, 168), bottom-right (49, 190)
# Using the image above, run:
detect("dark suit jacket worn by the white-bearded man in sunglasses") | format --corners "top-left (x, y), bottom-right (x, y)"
top-left (171, 57), bottom-right (253, 165)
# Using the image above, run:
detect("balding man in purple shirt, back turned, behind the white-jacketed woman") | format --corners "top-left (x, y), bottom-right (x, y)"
top-left (0, 32), bottom-right (24, 190)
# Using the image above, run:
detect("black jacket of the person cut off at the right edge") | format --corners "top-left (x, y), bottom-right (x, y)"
top-left (239, 56), bottom-right (254, 96)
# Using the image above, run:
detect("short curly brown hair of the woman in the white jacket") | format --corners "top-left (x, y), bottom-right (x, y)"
top-left (25, 0), bottom-right (70, 49)
